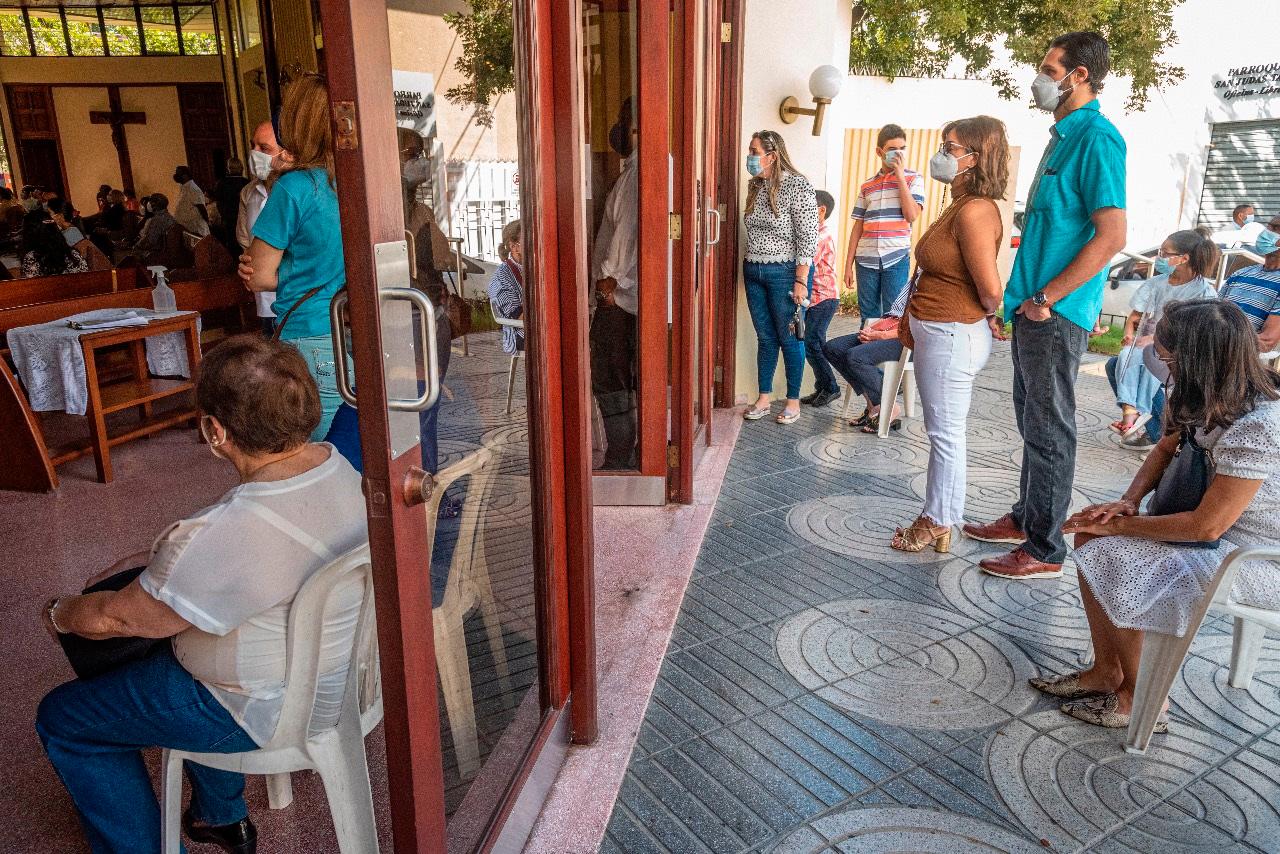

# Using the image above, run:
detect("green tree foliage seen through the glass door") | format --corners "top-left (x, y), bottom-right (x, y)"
top-left (444, 0), bottom-right (516, 128)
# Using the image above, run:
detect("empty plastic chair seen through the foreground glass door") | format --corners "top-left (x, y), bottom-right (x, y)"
top-left (425, 448), bottom-right (511, 780)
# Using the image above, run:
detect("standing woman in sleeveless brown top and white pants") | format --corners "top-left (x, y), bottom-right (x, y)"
top-left (890, 115), bottom-right (1009, 552)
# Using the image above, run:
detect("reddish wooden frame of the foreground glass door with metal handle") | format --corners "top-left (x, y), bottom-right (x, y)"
top-left (319, 0), bottom-right (595, 854)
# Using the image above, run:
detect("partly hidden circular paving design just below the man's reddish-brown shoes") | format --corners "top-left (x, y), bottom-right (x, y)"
top-left (938, 561), bottom-right (1091, 653)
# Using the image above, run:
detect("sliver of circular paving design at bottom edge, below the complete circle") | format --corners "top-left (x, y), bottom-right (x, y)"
top-left (772, 807), bottom-right (1043, 854)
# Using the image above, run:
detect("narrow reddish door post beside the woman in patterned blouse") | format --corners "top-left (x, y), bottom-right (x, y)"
top-left (713, 0), bottom-right (745, 408)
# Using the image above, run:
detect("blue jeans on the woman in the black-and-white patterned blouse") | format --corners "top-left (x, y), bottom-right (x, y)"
top-left (742, 261), bottom-right (813, 399)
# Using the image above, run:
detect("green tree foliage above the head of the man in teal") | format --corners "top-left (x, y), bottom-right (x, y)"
top-left (849, 0), bottom-right (1185, 110)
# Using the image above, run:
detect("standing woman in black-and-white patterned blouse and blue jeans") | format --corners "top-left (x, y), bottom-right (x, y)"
top-left (742, 131), bottom-right (818, 424)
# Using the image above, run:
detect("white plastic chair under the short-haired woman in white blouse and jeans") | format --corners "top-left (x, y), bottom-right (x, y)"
top-left (160, 544), bottom-right (381, 854)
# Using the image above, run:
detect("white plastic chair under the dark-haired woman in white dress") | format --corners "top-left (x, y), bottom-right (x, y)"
top-left (1124, 545), bottom-right (1280, 753)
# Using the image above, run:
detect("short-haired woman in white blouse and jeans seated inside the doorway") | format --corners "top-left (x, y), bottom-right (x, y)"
top-left (36, 335), bottom-right (367, 854)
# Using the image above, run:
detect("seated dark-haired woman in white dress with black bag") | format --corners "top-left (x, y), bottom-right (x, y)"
top-left (1030, 300), bottom-right (1280, 732)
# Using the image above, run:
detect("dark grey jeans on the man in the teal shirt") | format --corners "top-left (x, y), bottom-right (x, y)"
top-left (1012, 314), bottom-right (1089, 563)
